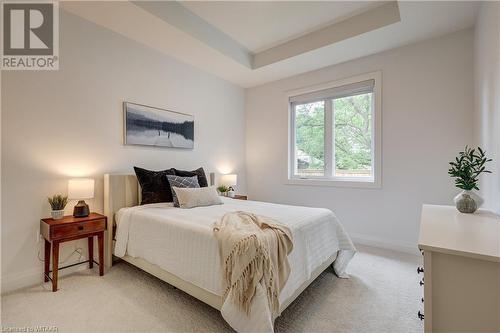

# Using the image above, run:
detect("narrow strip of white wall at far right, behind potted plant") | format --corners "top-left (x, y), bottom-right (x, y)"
top-left (474, 1), bottom-right (500, 214)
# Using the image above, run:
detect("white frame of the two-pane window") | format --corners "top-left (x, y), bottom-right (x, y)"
top-left (285, 71), bottom-right (382, 188)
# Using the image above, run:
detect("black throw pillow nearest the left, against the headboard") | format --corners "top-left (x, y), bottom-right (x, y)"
top-left (134, 167), bottom-right (175, 205)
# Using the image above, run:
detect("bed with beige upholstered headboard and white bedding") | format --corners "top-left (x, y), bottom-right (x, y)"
top-left (104, 174), bottom-right (355, 331)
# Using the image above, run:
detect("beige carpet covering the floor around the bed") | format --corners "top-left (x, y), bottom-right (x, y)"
top-left (2, 247), bottom-right (423, 333)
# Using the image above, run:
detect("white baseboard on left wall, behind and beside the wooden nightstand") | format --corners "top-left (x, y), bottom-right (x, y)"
top-left (0, 264), bottom-right (88, 295)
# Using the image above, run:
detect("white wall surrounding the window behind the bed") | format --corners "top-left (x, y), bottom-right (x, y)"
top-left (246, 30), bottom-right (474, 252)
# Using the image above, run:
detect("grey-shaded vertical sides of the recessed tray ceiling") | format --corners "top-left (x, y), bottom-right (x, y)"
top-left (133, 1), bottom-right (400, 69)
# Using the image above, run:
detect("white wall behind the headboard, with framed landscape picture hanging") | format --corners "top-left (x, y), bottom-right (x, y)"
top-left (1, 11), bottom-right (245, 292)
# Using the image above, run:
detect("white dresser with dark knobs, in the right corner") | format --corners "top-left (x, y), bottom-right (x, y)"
top-left (418, 205), bottom-right (500, 333)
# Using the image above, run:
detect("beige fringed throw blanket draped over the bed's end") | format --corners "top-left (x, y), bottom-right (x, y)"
top-left (214, 211), bottom-right (293, 315)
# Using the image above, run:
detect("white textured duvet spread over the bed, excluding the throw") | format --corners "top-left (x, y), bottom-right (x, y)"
top-left (114, 198), bottom-right (356, 332)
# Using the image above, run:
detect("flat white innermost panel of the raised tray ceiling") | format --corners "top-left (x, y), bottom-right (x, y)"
top-left (180, 1), bottom-right (374, 53)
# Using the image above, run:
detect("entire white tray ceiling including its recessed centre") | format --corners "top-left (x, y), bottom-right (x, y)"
top-left (61, 1), bottom-right (480, 87)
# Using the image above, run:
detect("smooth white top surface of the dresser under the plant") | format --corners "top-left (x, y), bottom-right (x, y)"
top-left (418, 205), bottom-right (500, 262)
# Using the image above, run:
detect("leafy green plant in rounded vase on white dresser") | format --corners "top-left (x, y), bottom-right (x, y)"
top-left (448, 146), bottom-right (491, 213)
